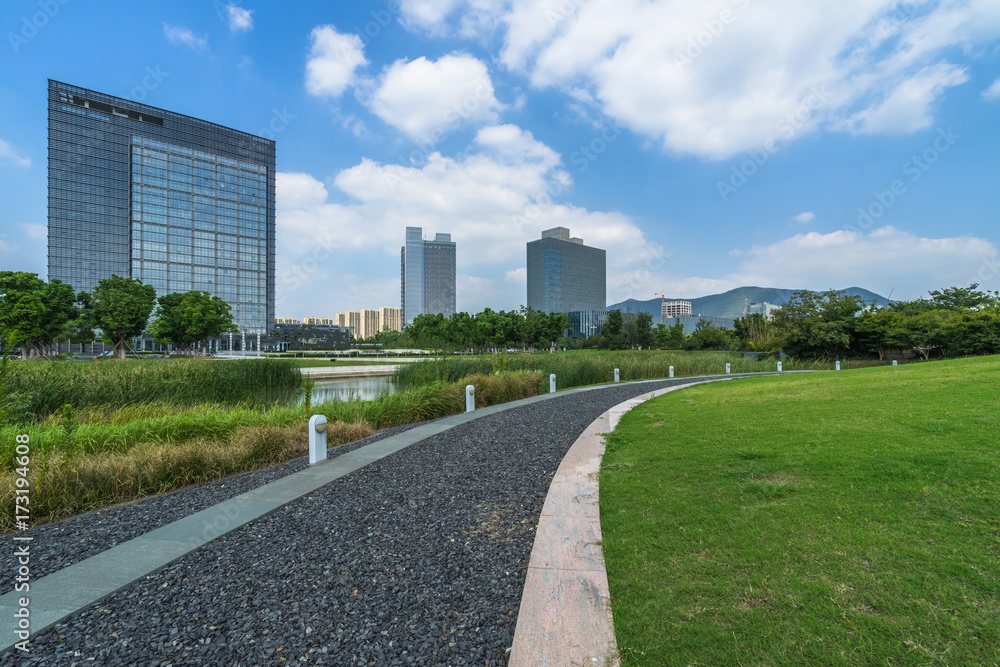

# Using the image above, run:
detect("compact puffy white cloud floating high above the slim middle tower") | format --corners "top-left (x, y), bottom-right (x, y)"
top-left (368, 53), bottom-right (502, 145)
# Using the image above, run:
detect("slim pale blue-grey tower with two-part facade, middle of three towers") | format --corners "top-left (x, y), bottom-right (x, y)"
top-left (399, 227), bottom-right (455, 325)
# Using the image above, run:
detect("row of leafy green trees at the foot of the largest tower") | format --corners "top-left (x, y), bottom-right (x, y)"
top-left (0, 271), bottom-right (235, 359)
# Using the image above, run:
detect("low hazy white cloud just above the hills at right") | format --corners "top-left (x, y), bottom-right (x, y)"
top-left (727, 227), bottom-right (997, 299)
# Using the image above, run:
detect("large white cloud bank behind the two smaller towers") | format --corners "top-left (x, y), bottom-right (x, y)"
top-left (277, 126), bottom-right (664, 313)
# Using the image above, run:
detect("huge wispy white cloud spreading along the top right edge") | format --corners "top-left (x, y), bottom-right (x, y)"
top-left (422, 0), bottom-right (1000, 159)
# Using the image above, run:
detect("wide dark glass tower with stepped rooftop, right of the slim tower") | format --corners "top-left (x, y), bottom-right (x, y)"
top-left (527, 227), bottom-right (607, 313)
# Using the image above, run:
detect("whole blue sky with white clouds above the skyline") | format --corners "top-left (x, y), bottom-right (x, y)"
top-left (0, 0), bottom-right (1000, 317)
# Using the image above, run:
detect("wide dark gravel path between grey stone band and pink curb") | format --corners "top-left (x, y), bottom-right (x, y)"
top-left (0, 378), bottom-right (728, 667)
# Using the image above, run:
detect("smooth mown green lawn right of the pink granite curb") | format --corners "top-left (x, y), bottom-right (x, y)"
top-left (600, 357), bottom-right (1000, 666)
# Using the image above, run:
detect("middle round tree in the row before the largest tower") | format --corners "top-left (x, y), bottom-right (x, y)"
top-left (92, 275), bottom-right (156, 359)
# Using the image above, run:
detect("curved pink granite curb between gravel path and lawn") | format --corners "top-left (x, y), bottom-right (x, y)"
top-left (509, 378), bottom-right (731, 667)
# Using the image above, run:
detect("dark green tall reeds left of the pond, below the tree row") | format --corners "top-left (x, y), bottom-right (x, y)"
top-left (6, 359), bottom-right (302, 424)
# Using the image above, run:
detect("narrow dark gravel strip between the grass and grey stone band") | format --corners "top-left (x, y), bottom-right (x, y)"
top-left (0, 422), bottom-right (426, 595)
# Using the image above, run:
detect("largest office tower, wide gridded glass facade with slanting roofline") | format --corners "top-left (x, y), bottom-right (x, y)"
top-left (49, 80), bottom-right (275, 333)
